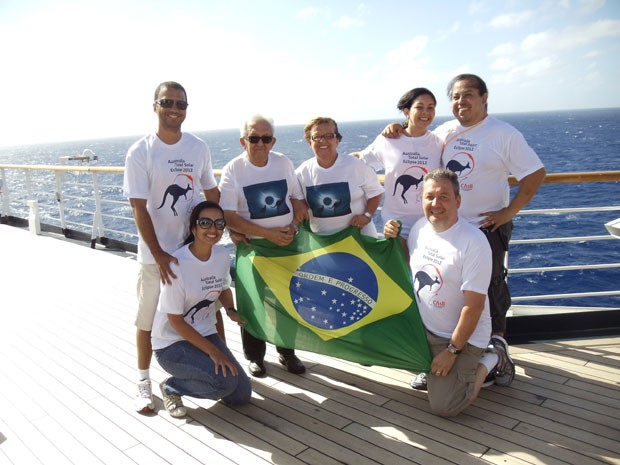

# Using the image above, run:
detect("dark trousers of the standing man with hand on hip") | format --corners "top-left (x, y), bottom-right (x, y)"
top-left (480, 221), bottom-right (513, 333)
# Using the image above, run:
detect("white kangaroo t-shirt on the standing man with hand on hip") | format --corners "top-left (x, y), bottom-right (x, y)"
top-left (434, 116), bottom-right (543, 225)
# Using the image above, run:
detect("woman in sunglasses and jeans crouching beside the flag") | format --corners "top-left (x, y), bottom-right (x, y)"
top-left (152, 201), bottom-right (252, 418)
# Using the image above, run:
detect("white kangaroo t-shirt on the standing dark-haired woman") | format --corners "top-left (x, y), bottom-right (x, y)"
top-left (360, 131), bottom-right (442, 239)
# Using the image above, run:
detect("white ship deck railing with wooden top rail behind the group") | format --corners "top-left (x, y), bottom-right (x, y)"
top-left (0, 162), bottom-right (620, 336)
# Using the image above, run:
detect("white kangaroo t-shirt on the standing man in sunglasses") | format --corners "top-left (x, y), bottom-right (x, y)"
top-left (123, 132), bottom-right (217, 264)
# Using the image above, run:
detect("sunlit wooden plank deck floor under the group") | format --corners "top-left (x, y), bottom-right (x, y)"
top-left (0, 225), bottom-right (620, 465)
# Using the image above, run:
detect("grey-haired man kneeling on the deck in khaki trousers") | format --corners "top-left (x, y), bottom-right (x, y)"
top-left (384, 169), bottom-right (514, 417)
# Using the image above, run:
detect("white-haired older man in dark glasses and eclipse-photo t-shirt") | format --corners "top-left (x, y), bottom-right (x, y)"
top-left (220, 115), bottom-right (306, 377)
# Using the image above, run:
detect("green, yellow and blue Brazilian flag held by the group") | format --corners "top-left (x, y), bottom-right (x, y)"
top-left (235, 223), bottom-right (431, 372)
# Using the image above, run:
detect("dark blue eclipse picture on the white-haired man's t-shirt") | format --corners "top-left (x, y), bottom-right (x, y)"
top-left (243, 179), bottom-right (291, 220)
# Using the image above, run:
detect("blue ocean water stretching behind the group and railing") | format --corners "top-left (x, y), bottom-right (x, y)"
top-left (0, 108), bottom-right (620, 307)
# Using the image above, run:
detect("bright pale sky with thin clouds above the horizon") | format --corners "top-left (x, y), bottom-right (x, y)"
top-left (0, 0), bottom-right (620, 146)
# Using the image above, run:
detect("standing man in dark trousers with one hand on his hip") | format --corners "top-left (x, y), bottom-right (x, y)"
top-left (383, 74), bottom-right (545, 389)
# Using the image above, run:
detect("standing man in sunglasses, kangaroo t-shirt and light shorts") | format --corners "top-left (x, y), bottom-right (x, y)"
top-left (123, 81), bottom-right (221, 413)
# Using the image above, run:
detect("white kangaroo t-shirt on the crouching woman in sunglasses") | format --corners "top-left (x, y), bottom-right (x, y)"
top-left (151, 245), bottom-right (231, 350)
